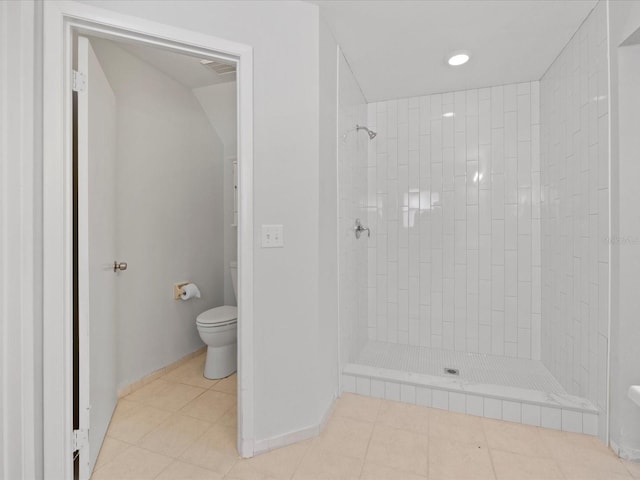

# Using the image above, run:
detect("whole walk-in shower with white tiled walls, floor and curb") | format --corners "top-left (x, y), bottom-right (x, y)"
top-left (339, 2), bottom-right (609, 438)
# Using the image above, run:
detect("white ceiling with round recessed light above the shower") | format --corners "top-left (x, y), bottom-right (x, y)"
top-left (311, 0), bottom-right (597, 102)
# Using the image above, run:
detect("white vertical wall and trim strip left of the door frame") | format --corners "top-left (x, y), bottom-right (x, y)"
top-left (0, 1), bottom-right (38, 479)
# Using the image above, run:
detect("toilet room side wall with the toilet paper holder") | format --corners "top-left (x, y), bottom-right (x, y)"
top-left (92, 39), bottom-right (224, 387)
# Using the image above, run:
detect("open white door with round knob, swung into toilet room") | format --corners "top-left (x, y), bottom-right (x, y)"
top-left (75, 37), bottom-right (119, 480)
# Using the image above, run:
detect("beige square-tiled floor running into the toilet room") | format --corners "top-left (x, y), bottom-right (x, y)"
top-left (92, 355), bottom-right (640, 480)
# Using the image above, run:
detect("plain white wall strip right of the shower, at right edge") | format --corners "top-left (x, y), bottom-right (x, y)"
top-left (608, 1), bottom-right (640, 460)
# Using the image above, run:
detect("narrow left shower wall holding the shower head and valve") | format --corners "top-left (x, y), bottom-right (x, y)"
top-left (337, 52), bottom-right (368, 368)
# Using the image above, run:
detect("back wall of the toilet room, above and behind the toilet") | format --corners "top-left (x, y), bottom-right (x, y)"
top-left (193, 82), bottom-right (238, 305)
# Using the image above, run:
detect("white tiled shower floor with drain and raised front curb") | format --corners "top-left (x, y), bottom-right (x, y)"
top-left (343, 341), bottom-right (599, 418)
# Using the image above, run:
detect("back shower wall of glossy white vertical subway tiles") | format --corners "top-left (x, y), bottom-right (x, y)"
top-left (366, 82), bottom-right (541, 359)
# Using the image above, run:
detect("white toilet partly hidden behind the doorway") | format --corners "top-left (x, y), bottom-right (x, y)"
top-left (196, 262), bottom-right (238, 380)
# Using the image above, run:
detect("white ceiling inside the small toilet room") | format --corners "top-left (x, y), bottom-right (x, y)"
top-left (118, 42), bottom-right (236, 90)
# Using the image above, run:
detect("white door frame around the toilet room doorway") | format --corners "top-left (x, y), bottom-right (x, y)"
top-left (43, 1), bottom-right (255, 479)
